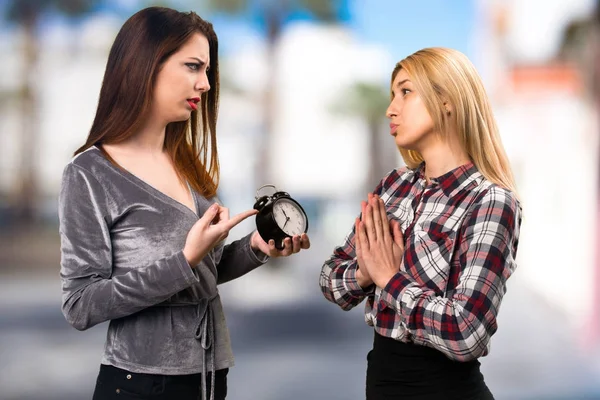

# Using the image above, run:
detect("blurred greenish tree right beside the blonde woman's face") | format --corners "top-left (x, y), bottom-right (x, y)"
top-left (333, 82), bottom-right (398, 195)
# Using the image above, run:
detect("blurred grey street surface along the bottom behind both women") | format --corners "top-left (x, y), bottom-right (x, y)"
top-left (0, 231), bottom-right (600, 400)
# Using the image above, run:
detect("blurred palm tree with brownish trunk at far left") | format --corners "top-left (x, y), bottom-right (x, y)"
top-left (6, 0), bottom-right (100, 224)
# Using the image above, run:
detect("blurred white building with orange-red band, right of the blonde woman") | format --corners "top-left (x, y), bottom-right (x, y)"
top-left (474, 0), bottom-right (600, 345)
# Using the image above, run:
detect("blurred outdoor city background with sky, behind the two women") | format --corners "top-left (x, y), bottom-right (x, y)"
top-left (0, 0), bottom-right (600, 400)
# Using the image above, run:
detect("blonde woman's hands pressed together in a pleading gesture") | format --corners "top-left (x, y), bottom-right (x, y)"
top-left (354, 193), bottom-right (404, 288)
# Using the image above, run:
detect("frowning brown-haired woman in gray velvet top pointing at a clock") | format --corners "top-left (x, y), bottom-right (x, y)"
top-left (59, 7), bottom-right (310, 400)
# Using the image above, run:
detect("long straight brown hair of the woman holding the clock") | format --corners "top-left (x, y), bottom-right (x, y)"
top-left (74, 7), bottom-right (219, 197)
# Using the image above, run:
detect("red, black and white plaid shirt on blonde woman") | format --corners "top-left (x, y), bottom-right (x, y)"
top-left (319, 163), bottom-right (521, 361)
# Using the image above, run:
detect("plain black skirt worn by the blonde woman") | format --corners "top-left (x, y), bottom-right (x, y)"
top-left (366, 332), bottom-right (494, 400)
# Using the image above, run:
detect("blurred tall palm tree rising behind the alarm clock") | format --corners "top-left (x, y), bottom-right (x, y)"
top-left (208, 0), bottom-right (340, 186)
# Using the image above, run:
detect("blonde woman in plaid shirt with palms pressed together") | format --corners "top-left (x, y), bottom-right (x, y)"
top-left (320, 48), bottom-right (521, 400)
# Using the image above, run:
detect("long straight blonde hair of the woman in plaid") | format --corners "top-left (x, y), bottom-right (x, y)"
top-left (392, 47), bottom-right (517, 195)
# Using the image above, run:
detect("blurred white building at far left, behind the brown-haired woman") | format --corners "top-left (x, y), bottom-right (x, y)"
top-left (0, 14), bottom-right (122, 218)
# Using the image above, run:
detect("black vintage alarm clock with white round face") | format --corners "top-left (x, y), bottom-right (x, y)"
top-left (254, 185), bottom-right (308, 250)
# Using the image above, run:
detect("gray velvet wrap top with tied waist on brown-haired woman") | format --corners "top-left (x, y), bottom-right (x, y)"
top-left (59, 147), bottom-right (268, 381)
